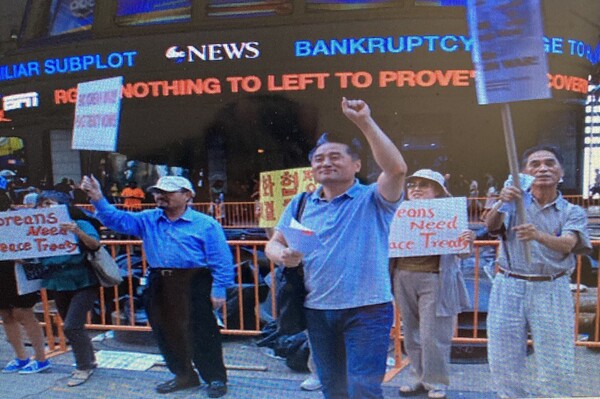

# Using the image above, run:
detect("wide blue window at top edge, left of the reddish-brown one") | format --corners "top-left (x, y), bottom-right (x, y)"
top-left (116, 0), bottom-right (192, 26)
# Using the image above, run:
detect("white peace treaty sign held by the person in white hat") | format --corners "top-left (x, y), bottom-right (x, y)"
top-left (389, 197), bottom-right (470, 258)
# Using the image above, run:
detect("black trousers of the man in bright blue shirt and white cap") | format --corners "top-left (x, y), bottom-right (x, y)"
top-left (145, 268), bottom-right (227, 383)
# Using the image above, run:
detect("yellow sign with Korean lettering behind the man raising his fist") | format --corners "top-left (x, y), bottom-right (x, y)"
top-left (259, 167), bottom-right (317, 227)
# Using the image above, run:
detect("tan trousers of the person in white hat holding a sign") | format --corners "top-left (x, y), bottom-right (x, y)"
top-left (392, 269), bottom-right (456, 389)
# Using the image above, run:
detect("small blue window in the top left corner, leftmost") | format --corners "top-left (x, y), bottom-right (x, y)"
top-left (48, 0), bottom-right (95, 36)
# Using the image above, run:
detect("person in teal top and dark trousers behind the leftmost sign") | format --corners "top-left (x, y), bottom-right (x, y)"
top-left (36, 190), bottom-right (100, 387)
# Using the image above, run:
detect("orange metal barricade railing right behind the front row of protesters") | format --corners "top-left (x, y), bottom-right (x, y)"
top-left (37, 240), bottom-right (600, 366)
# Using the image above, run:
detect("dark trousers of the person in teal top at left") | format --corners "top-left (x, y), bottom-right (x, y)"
top-left (53, 286), bottom-right (98, 370)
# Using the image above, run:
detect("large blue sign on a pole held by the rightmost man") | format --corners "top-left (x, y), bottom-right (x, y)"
top-left (467, 0), bottom-right (551, 104)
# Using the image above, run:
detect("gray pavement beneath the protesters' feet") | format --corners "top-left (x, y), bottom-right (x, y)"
top-left (0, 329), bottom-right (600, 399)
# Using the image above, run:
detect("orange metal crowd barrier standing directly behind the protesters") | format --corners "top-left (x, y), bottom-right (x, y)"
top-left (10, 240), bottom-right (600, 380)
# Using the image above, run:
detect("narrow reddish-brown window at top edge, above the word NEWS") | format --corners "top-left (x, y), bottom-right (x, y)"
top-left (208, 0), bottom-right (294, 18)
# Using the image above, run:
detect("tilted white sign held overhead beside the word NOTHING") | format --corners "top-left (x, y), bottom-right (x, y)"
top-left (72, 76), bottom-right (123, 151)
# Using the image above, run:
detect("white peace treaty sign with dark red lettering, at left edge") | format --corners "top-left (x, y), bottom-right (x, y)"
top-left (0, 205), bottom-right (79, 260)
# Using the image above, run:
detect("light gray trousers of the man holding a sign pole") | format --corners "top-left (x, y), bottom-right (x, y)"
top-left (487, 274), bottom-right (575, 398)
